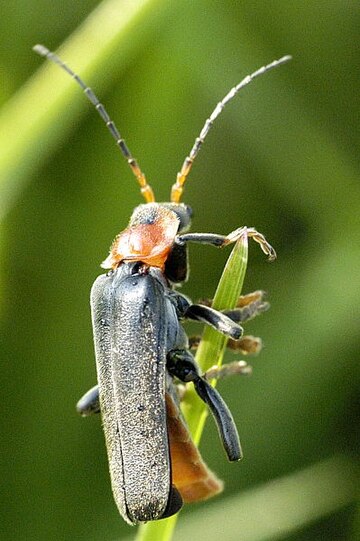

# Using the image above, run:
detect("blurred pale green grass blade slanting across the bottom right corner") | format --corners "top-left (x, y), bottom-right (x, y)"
top-left (130, 454), bottom-right (359, 541)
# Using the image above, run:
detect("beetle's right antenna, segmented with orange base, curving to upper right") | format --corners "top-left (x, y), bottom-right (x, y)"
top-left (171, 55), bottom-right (291, 203)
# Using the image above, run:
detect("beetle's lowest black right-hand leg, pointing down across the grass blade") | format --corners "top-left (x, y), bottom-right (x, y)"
top-left (167, 349), bottom-right (242, 461)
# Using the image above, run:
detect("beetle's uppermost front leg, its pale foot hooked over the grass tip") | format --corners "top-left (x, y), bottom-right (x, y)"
top-left (175, 227), bottom-right (276, 261)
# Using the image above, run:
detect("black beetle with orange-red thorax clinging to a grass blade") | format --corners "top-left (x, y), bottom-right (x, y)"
top-left (34, 45), bottom-right (290, 524)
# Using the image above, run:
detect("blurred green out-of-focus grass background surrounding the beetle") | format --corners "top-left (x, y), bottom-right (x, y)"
top-left (0, 0), bottom-right (360, 541)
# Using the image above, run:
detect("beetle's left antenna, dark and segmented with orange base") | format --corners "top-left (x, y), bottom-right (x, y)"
top-left (33, 45), bottom-right (155, 203)
